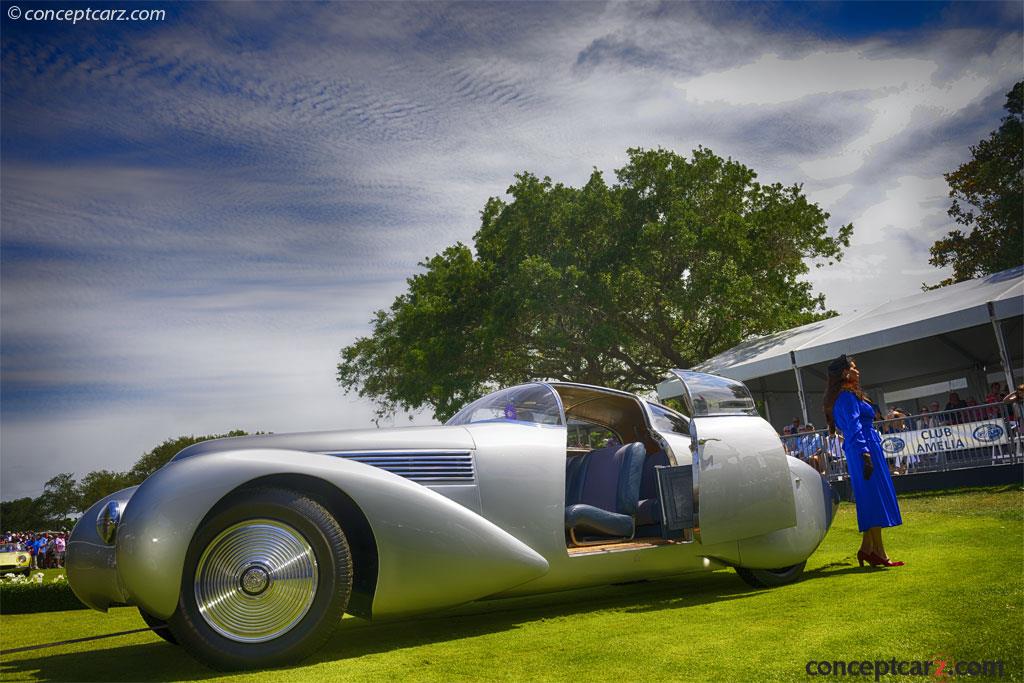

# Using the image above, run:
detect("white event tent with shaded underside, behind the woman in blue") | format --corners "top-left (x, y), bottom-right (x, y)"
top-left (695, 266), bottom-right (1024, 422)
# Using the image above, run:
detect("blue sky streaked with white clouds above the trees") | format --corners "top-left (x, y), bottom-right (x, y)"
top-left (0, 1), bottom-right (1024, 500)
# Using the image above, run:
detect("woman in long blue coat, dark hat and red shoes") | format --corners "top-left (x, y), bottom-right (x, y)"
top-left (824, 353), bottom-right (903, 566)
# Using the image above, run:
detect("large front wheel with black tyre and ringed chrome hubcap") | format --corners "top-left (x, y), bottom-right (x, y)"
top-left (168, 488), bottom-right (352, 670)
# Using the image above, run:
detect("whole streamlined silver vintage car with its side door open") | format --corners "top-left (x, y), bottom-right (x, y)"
top-left (68, 371), bottom-right (838, 668)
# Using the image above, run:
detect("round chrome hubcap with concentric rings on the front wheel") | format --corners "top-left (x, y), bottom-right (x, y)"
top-left (195, 519), bottom-right (317, 643)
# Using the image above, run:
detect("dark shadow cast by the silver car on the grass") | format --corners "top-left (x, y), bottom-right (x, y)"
top-left (0, 571), bottom-right (762, 681)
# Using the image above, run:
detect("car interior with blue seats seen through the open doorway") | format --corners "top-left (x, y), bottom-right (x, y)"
top-left (552, 384), bottom-right (680, 555)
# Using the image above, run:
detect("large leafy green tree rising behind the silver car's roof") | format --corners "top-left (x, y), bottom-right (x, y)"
top-left (338, 147), bottom-right (853, 420)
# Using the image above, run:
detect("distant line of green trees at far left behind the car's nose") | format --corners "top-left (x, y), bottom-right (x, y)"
top-left (0, 429), bottom-right (249, 531)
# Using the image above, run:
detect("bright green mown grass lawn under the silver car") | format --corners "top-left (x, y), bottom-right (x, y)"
top-left (0, 486), bottom-right (1024, 683)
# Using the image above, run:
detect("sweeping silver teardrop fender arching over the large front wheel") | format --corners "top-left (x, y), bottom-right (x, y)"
top-left (117, 450), bottom-right (548, 618)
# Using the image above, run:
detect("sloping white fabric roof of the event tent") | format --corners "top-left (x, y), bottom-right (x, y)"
top-left (694, 266), bottom-right (1024, 381)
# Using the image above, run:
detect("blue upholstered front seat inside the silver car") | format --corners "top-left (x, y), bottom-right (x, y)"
top-left (565, 442), bottom-right (646, 538)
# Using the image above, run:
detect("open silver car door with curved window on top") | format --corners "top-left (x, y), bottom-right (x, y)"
top-left (657, 370), bottom-right (797, 545)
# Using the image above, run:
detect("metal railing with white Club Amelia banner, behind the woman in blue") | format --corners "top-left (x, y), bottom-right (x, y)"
top-left (781, 403), bottom-right (1024, 481)
